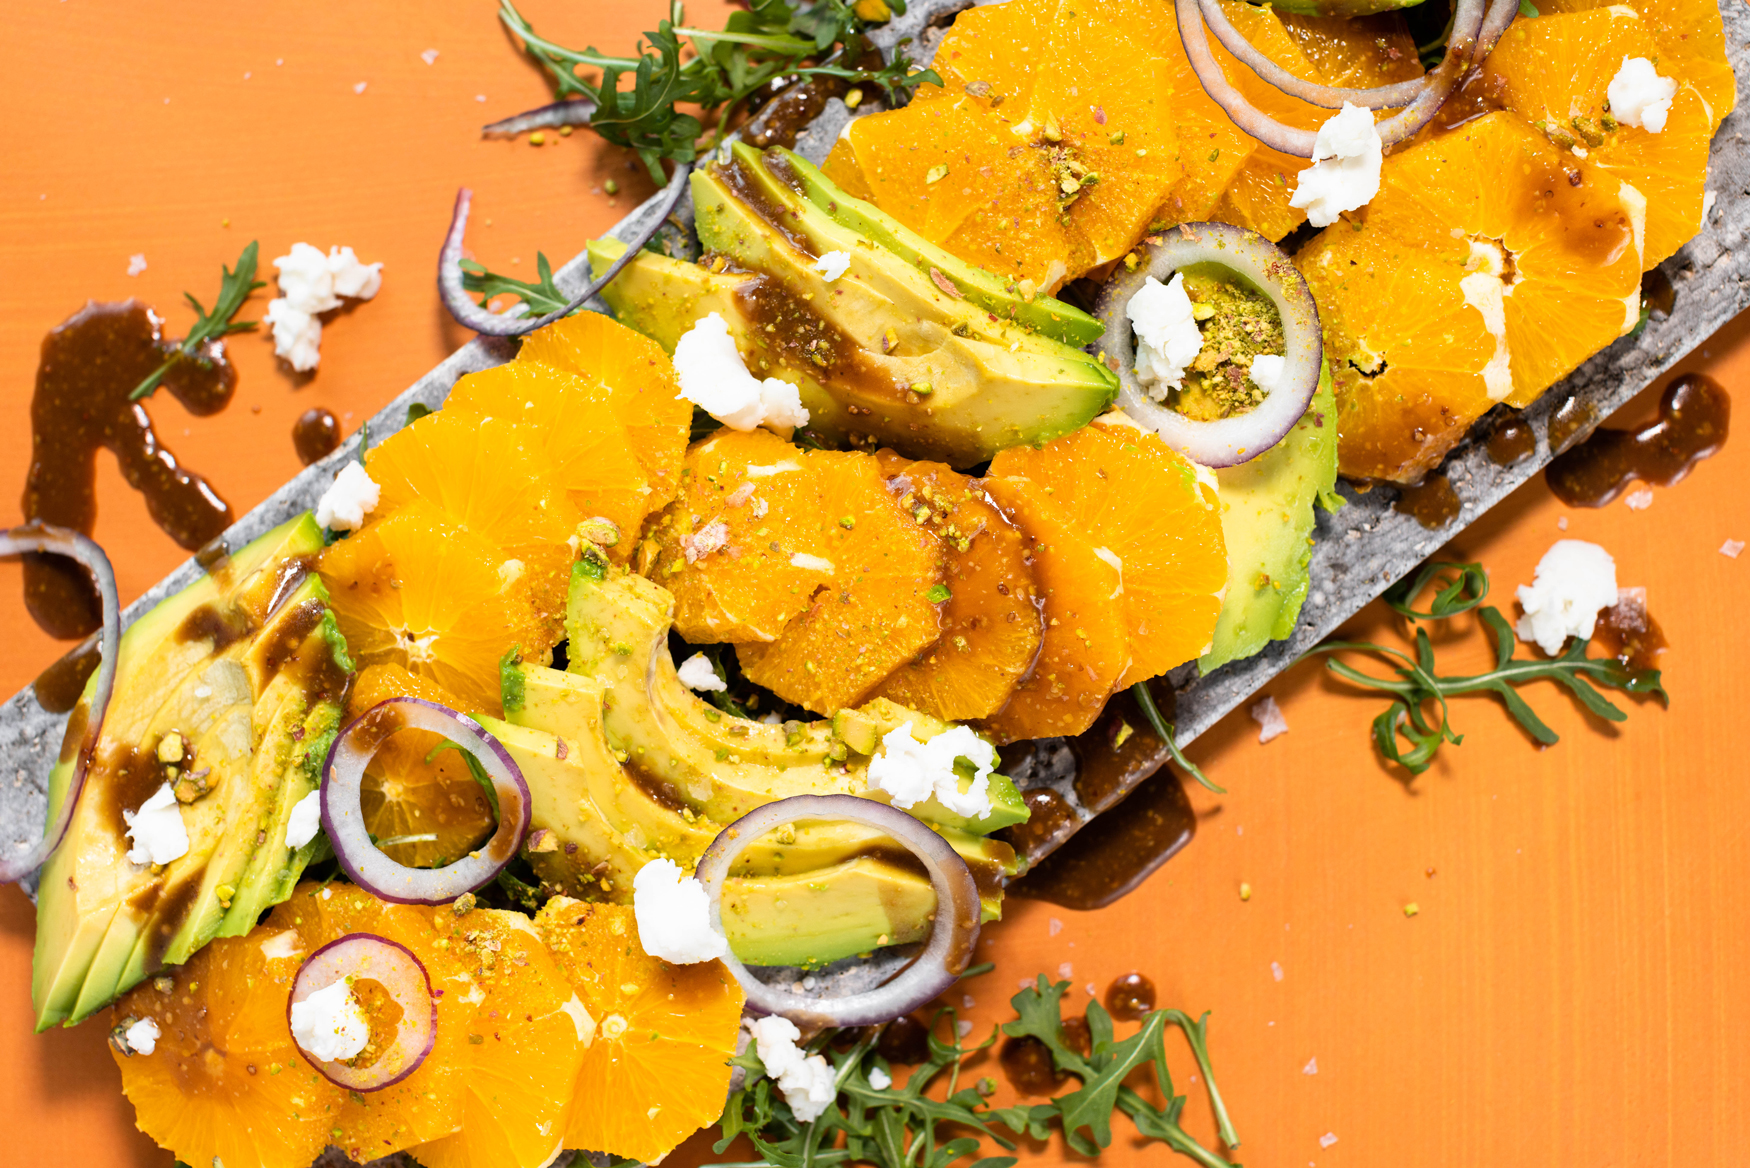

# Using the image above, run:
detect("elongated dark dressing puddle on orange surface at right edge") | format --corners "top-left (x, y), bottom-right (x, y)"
top-left (1544, 373), bottom-right (1733, 506)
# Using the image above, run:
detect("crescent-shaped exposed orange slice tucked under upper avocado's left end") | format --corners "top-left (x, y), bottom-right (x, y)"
top-left (516, 312), bottom-right (693, 511)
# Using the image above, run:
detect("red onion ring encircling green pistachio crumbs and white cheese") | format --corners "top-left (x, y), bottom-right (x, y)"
top-left (1096, 222), bottom-right (1325, 468)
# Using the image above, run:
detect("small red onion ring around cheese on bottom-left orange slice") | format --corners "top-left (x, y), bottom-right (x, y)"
top-left (285, 933), bottom-right (438, 1091)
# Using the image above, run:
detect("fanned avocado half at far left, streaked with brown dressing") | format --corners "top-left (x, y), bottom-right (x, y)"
top-left (32, 515), bottom-right (343, 1030)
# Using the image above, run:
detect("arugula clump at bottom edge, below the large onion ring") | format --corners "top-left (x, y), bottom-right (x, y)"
top-left (716, 975), bottom-right (1239, 1168)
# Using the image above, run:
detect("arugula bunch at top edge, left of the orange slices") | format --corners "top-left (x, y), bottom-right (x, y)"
top-left (499, 0), bottom-right (942, 186)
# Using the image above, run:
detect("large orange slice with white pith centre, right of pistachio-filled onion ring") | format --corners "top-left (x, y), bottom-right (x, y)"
top-left (1297, 112), bottom-right (1642, 482)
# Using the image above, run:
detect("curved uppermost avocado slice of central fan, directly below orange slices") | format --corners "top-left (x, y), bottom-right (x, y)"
top-left (556, 559), bottom-right (1027, 835)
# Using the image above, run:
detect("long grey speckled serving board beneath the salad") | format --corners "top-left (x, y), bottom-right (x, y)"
top-left (0, 0), bottom-right (1750, 896)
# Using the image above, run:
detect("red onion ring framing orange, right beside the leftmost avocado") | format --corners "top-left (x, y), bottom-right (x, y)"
top-left (322, 697), bottom-right (530, 904)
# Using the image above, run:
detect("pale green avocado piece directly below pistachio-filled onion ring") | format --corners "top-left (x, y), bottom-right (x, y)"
top-left (1197, 369), bottom-right (1337, 672)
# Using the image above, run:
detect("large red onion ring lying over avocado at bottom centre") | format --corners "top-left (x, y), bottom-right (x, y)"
top-left (693, 795), bottom-right (980, 1026)
